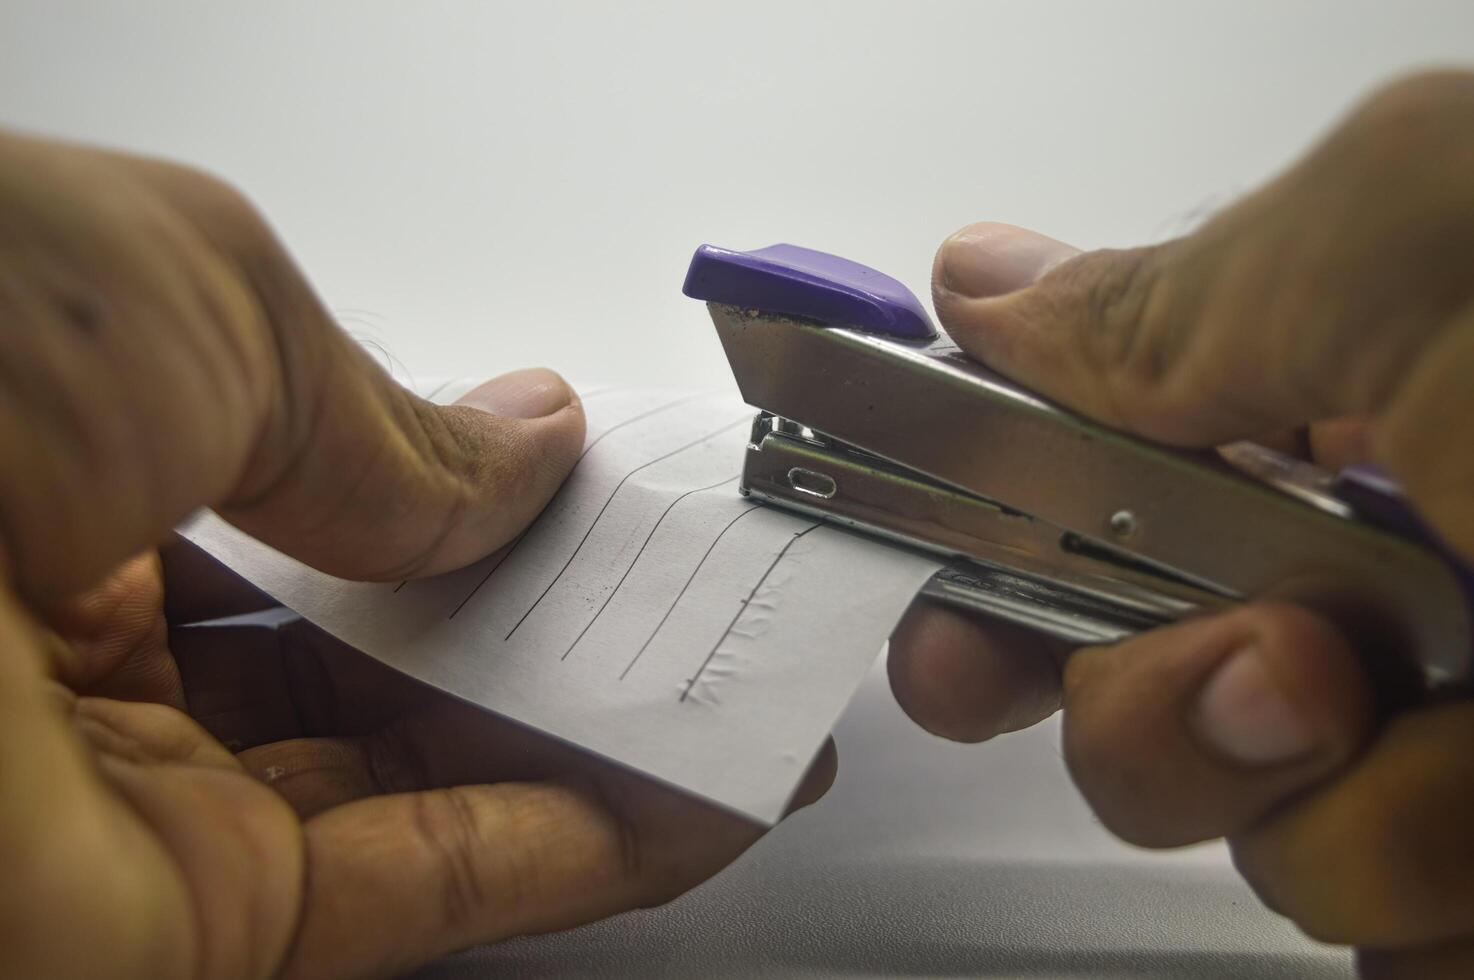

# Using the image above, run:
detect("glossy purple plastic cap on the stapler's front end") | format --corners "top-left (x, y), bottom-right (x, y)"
top-left (681, 245), bottom-right (936, 340)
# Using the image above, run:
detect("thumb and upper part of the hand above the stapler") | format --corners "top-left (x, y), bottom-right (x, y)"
top-left (933, 72), bottom-right (1474, 553)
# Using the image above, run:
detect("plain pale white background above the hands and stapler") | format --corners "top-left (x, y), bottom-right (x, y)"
top-left (0, 0), bottom-right (1474, 385)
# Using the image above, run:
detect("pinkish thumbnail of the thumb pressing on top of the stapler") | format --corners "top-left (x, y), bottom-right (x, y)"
top-left (940, 221), bottom-right (1080, 299)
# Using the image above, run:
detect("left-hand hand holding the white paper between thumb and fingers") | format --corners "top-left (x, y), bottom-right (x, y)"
top-left (0, 134), bottom-right (833, 979)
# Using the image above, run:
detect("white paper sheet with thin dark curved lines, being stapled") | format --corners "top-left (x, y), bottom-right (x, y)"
top-left (181, 383), bottom-right (937, 822)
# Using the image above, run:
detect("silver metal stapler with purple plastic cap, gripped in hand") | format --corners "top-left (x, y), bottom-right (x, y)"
top-left (684, 245), bottom-right (1474, 688)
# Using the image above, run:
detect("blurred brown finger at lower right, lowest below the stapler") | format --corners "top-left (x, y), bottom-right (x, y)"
top-left (1229, 703), bottom-right (1474, 949)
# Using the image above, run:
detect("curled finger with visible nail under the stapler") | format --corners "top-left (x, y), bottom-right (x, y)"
top-left (1064, 604), bottom-right (1372, 847)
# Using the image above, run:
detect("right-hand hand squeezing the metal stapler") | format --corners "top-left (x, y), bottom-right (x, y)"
top-left (890, 74), bottom-right (1474, 980)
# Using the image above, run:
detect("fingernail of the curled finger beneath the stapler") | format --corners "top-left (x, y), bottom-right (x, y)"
top-left (1197, 647), bottom-right (1316, 766)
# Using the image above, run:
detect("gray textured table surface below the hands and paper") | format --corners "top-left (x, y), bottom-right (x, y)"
top-left (416, 657), bottom-right (1352, 980)
